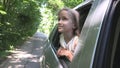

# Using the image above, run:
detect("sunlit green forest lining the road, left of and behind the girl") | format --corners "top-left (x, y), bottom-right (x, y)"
top-left (0, 0), bottom-right (84, 57)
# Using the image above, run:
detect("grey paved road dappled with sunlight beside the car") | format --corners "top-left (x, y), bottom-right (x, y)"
top-left (0, 32), bottom-right (47, 68)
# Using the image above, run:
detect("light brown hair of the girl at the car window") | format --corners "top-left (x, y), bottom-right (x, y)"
top-left (58, 8), bottom-right (79, 35)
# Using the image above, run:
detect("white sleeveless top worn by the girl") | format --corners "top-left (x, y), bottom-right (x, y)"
top-left (60, 34), bottom-right (78, 52)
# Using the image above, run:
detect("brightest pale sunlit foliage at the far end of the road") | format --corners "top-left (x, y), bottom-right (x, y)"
top-left (39, 7), bottom-right (53, 34)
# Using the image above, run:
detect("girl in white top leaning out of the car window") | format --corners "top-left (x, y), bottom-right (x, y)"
top-left (57, 8), bottom-right (79, 62)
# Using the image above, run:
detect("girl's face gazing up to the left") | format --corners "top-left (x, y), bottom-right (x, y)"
top-left (58, 10), bottom-right (75, 33)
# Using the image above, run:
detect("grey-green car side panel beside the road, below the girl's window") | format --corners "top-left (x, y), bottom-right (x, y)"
top-left (40, 41), bottom-right (62, 68)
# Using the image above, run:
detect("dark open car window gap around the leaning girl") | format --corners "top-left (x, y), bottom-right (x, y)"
top-left (49, 1), bottom-right (92, 51)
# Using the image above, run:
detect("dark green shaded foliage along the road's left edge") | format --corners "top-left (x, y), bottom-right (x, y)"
top-left (0, 0), bottom-right (40, 50)
